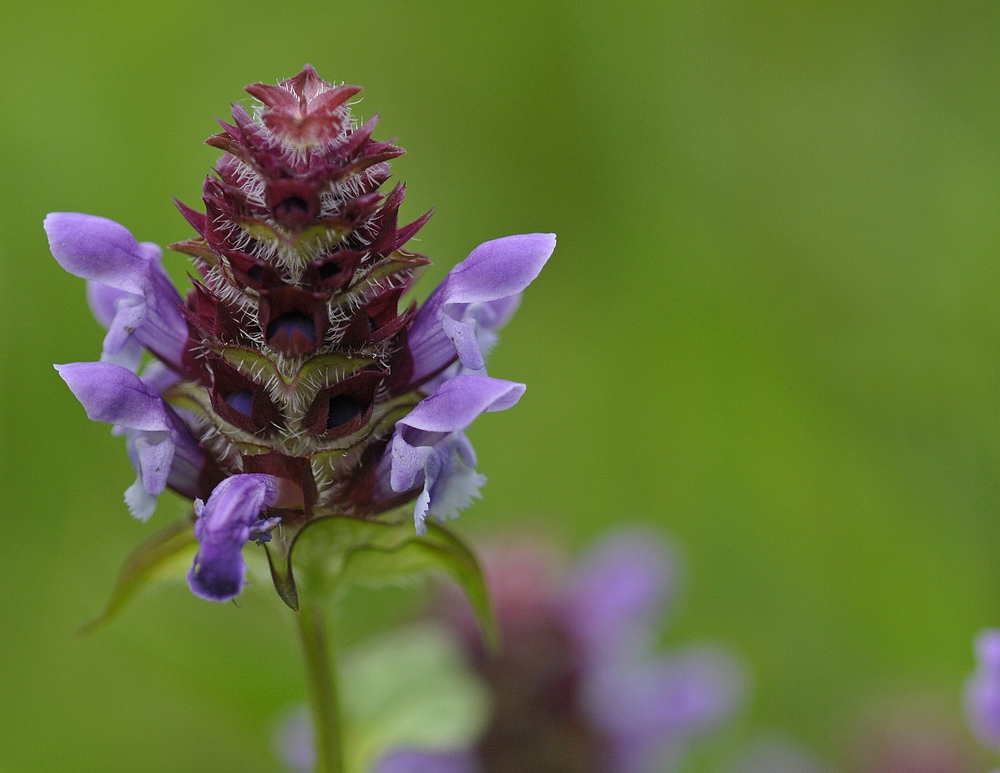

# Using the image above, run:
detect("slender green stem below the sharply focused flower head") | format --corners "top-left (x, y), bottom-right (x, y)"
top-left (297, 599), bottom-right (344, 773)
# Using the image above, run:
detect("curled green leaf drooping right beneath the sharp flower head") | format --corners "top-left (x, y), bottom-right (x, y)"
top-left (292, 516), bottom-right (499, 649)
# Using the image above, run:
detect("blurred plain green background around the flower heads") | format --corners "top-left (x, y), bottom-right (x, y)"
top-left (0, 0), bottom-right (1000, 771)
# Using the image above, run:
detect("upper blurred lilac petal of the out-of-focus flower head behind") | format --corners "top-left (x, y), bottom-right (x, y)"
top-left (565, 531), bottom-right (676, 659)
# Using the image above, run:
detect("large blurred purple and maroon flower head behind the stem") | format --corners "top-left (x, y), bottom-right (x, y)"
top-left (360, 533), bottom-right (742, 773)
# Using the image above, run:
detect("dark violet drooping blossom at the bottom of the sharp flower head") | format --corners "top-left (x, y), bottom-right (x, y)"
top-left (187, 474), bottom-right (278, 601)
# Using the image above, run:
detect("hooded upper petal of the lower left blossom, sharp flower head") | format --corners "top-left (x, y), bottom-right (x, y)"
top-left (55, 362), bottom-right (170, 431)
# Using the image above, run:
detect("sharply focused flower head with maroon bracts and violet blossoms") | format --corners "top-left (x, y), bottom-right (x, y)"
top-left (45, 65), bottom-right (555, 601)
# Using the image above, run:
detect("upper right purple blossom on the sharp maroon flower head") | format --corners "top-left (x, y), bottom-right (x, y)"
top-left (409, 234), bottom-right (556, 385)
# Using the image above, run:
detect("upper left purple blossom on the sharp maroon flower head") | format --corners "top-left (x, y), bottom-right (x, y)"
top-left (45, 212), bottom-right (187, 368)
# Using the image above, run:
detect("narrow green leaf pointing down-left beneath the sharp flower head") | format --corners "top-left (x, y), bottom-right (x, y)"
top-left (77, 518), bottom-right (198, 635)
